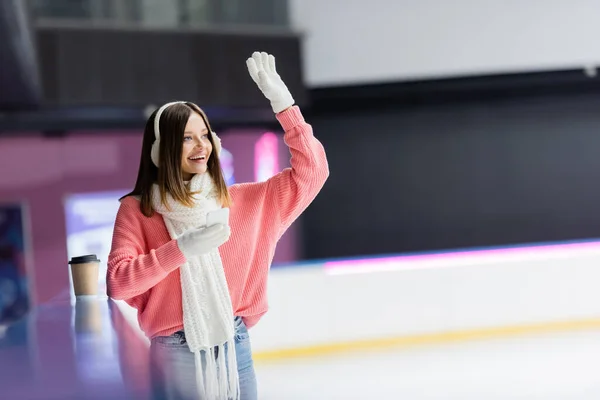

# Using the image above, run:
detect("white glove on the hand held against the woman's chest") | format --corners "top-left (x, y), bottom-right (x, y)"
top-left (177, 224), bottom-right (231, 259)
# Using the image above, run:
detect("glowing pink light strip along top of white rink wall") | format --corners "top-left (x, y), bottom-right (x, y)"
top-left (324, 242), bottom-right (600, 274)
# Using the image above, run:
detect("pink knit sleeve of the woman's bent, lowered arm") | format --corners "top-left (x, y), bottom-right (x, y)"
top-left (106, 201), bottom-right (186, 300)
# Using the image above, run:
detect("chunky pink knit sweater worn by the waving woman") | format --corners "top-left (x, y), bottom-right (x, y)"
top-left (106, 106), bottom-right (329, 338)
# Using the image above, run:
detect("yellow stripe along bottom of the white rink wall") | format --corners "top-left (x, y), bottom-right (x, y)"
top-left (252, 318), bottom-right (600, 361)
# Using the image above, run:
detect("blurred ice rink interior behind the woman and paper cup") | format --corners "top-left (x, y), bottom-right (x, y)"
top-left (0, 0), bottom-right (600, 399)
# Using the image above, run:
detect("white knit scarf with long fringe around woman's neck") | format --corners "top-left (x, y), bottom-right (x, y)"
top-left (152, 172), bottom-right (239, 400)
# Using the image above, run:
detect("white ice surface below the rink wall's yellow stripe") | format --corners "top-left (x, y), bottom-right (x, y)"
top-left (256, 330), bottom-right (600, 400)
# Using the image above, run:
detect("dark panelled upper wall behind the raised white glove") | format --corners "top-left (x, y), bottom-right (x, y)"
top-left (36, 23), bottom-right (306, 108)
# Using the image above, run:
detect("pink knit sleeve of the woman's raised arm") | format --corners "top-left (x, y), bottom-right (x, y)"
top-left (267, 106), bottom-right (329, 234)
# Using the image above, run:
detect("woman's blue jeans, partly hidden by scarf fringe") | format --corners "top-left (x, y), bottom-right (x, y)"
top-left (150, 317), bottom-right (258, 400)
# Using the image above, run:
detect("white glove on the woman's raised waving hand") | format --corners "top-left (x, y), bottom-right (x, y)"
top-left (246, 52), bottom-right (294, 114)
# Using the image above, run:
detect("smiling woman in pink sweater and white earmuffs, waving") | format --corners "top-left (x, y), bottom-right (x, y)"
top-left (107, 53), bottom-right (329, 400)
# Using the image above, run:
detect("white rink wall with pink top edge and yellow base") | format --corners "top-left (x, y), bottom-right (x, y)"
top-left (113, 241), bottom-right (600, 360)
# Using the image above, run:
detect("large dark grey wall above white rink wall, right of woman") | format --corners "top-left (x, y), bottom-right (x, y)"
top-left (303, 89), bottom-right (600, 258)
